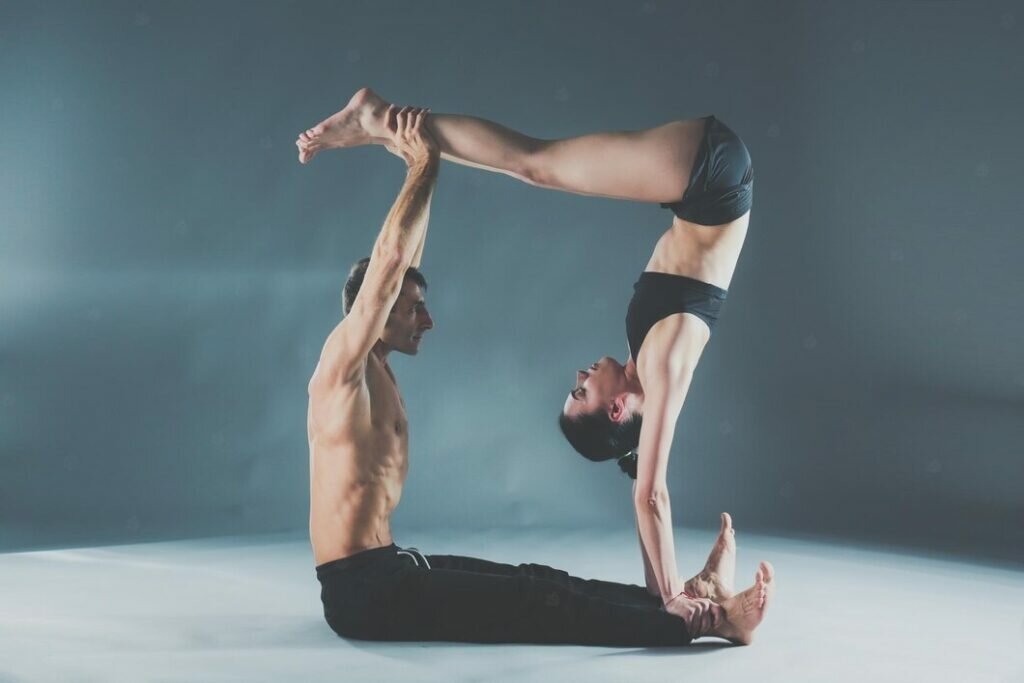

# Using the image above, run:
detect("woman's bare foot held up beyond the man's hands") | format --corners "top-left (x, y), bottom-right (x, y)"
top-left (295, 88), bottom-right (390, 164)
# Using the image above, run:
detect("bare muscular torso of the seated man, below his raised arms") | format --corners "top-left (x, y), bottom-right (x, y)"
top-left (307, 351), bottom-right (409, 564)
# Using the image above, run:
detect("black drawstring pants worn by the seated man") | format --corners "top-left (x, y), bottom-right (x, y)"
top-left (316, 545), bottom-right (690, 647)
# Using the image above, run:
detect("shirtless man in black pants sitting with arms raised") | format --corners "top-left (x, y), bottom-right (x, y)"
top-left (308, 101), bottom-right (771, 646)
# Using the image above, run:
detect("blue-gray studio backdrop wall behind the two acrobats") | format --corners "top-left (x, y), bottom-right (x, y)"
top-left (0, 0), bottom-right (1024, 561)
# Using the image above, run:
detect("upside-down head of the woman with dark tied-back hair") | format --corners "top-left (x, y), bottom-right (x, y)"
top-left (558, 356), bottom-right (643, 461)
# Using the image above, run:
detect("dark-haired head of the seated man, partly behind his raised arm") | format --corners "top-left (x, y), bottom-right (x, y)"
top-left (342, 257), bottom-right (434, 355)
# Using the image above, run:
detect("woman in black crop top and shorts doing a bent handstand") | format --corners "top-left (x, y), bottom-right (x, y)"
top-left (296, 89), bottom-right (774, 638)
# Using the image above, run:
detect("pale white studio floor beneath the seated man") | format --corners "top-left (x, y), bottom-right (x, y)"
top-left (0, 528), bottom-right (1024, 683)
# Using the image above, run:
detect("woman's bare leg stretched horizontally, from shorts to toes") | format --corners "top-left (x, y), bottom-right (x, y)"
top-left (296, 88), bottom-right (703, 202)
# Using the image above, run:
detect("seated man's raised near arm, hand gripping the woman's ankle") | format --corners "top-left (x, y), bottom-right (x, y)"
top-left (310, 109), bottom-right (440, 389)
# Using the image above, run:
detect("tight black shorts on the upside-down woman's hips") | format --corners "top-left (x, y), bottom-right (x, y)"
top-left (662, 116), bottom-right (754, 225)
